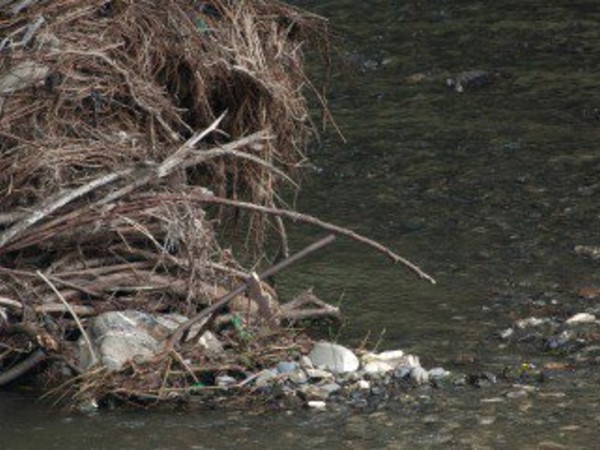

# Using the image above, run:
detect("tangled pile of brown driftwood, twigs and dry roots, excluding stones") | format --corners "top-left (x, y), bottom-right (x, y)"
top-left (0, 0), bottom-right (431, 408)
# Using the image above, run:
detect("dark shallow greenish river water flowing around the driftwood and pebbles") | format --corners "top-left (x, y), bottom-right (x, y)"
top-left (0, 0), bottom-right (600, 449)
